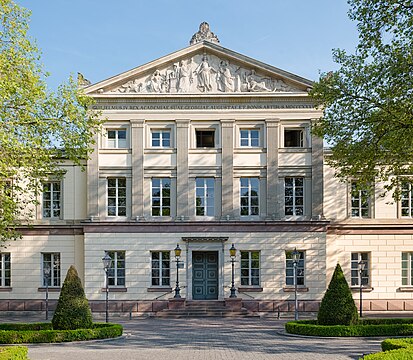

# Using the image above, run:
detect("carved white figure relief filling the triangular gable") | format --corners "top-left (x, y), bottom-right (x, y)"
top-left (112, 53), bottom-right (300, 94)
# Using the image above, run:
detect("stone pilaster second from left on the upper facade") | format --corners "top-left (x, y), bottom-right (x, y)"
top-left (131, 119), bottom-right (145, 219)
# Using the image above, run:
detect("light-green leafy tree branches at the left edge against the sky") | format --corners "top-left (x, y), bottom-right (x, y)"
top-left (0, 0), bottom-right (100, 245)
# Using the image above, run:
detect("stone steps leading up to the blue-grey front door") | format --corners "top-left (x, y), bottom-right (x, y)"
top-left (156, 300), bottom-right (254, 318)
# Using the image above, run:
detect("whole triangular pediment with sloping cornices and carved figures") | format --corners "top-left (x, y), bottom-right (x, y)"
top-left (85, 41), bottom-right (312, 96)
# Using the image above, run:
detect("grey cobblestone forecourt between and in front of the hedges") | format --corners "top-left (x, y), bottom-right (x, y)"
top-left (16, 318), bottom-right (381, 360)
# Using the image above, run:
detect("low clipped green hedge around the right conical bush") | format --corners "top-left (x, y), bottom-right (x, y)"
top-left (285, 319), bottom-right (413, 337)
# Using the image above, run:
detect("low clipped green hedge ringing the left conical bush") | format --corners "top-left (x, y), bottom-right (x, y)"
top-left (0, 323), bottom-right (123, 344)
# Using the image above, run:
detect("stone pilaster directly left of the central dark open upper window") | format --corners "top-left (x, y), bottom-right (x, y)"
top-left (176, 119), bottom-right (190, 220)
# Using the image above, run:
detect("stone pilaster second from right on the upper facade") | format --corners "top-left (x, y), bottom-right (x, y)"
top-left (265, 119), bottom-right (282, 220)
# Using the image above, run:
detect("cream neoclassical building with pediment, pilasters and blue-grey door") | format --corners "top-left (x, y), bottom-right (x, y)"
top-left (0, 23), bottom-right (413, 313)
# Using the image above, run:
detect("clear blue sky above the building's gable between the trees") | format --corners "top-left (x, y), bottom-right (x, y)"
top-left (15, 0), bottom-right (357, 88)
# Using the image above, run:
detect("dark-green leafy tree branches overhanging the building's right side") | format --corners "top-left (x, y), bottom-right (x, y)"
top-left (310, 0), bottom-right (413, 198)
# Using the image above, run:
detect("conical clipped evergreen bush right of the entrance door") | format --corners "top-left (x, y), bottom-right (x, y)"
top-left (317, 264), bottom-right (358, 325)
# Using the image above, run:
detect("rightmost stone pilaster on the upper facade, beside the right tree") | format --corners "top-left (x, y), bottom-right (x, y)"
top-left (311, 119), bottom-right (324, 220)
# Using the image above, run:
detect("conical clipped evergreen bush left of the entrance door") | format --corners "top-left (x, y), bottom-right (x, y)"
top-left (52, 265), bottom-right (93, 330)
